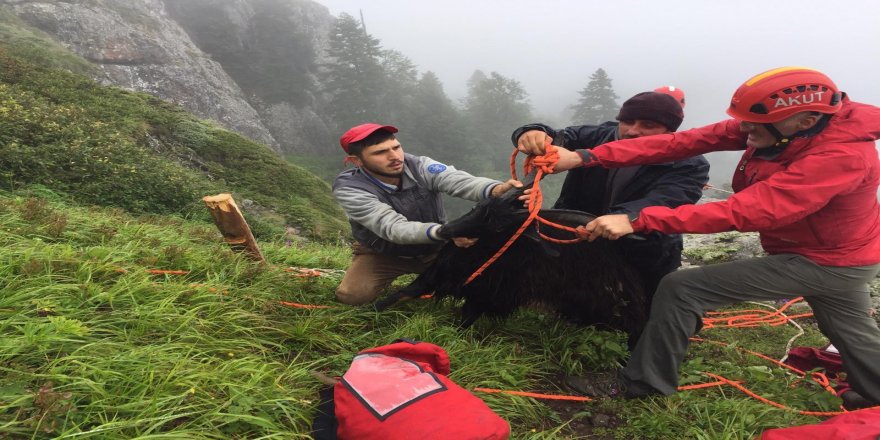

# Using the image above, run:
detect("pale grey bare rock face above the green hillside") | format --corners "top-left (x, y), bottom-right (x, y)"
top-left (4, 0), bottom-right (288, 149)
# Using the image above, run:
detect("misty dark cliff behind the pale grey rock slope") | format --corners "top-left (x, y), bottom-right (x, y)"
top-left (166, 0), bottom-right (335, 154)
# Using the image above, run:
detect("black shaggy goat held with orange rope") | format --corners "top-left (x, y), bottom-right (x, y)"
top-left (376, 180), bottom-right (650, 341)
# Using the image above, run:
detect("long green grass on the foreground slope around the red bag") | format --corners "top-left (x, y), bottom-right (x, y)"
top-left (0, 187), bottom-right (852, 439)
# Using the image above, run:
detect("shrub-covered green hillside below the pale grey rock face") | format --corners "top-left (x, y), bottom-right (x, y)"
top-left (0, 7), bottom-right (350, 242)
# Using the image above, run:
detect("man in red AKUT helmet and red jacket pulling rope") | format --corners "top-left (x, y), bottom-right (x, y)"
top-left (520, 67), bottom-right (880, 407)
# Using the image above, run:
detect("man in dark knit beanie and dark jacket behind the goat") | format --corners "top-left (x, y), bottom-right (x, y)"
top-left (512, 88), bottom-right (709, 304)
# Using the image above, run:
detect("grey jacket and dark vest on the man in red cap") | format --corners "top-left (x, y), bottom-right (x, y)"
top-left (333, 154), bottom-right (501, 256)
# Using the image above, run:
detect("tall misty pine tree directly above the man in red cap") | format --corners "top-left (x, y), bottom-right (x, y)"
top-left (322, 13), bottom-right (385, 130)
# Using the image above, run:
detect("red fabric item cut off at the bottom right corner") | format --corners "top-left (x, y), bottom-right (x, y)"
top-left (761, 409), bottom-right (880, 440)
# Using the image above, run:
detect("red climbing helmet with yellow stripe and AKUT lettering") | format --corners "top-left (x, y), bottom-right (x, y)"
top-left (727, 67), bottom-right (841, 124)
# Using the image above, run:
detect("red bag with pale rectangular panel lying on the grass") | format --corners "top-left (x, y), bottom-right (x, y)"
top-left (333, 341), bottom-right (510, 440)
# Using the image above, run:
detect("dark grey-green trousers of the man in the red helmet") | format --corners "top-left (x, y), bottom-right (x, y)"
top-left (623, 254), bottom-right (880, 402)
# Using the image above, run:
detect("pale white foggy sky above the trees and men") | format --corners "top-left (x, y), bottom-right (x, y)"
top-left (317, 0), bottom-right (880, 185)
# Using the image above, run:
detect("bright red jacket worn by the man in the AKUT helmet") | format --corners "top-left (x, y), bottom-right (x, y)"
top-left (591, 98), bottom-right (880, 266)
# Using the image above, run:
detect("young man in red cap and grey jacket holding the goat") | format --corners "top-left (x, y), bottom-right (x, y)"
top-left (333, 123), bottom-right (522, 305)
